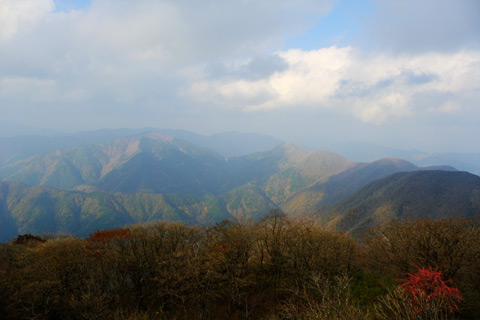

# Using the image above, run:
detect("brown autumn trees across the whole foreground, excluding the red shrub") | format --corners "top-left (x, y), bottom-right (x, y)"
top-left (0, 216), bottom-right (480, 320)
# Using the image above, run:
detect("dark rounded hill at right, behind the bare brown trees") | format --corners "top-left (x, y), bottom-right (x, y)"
top-left (317, 170), bottom-right (480, 238)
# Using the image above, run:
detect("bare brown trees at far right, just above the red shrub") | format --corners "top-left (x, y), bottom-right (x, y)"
top-left (364, 218), bottom-right (480, 318)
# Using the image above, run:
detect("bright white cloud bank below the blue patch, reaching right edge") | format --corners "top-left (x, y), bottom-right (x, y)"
top-left (186, 47), bottom-right (480, 124)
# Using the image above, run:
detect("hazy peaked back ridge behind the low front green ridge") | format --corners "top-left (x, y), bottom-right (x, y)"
top-left (0, 133), bottom-right (353, 199)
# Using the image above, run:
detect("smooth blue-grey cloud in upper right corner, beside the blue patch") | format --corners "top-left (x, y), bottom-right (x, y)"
top-left (362, 0), bottom-right (480, 53)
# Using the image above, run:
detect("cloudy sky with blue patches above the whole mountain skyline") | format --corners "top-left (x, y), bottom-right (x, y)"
top-left (0, 0), bottom-right (480, 152)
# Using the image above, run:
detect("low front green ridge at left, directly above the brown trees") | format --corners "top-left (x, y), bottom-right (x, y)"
top-left (0, 182), bottom-right (277, 241)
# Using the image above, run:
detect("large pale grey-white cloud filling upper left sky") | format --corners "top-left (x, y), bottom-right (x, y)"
top-left (0, 0), bottom-right (332, 114)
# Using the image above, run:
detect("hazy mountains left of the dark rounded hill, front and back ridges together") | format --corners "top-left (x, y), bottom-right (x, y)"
top-left (0, 133), bottom-right (353, 240)
